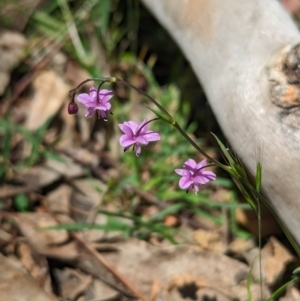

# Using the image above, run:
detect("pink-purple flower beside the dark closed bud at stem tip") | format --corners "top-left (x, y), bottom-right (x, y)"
top-left (77, 87), bottom-right (114, 119)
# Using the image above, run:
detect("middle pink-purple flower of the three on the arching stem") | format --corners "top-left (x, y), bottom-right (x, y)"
top-left (119, 120), bottom-right (160, 156)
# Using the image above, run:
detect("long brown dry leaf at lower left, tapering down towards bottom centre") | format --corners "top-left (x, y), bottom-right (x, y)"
top-left (5, 213), bottom-right (132, 301)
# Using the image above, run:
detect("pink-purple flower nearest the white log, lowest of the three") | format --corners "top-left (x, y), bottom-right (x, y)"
top-left (175, 159), bottom-right (216, 194)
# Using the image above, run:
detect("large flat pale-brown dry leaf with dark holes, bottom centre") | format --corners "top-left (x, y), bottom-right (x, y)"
top-left (104, 240), bottom-right (268, 301)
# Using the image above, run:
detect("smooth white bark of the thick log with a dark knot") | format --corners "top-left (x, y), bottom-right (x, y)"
top-left (143, 0), bottom-right (300, 243)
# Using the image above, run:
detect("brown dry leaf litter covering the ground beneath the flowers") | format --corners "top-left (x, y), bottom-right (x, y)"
top-left (0, 1), bottom-right (300, 301)
